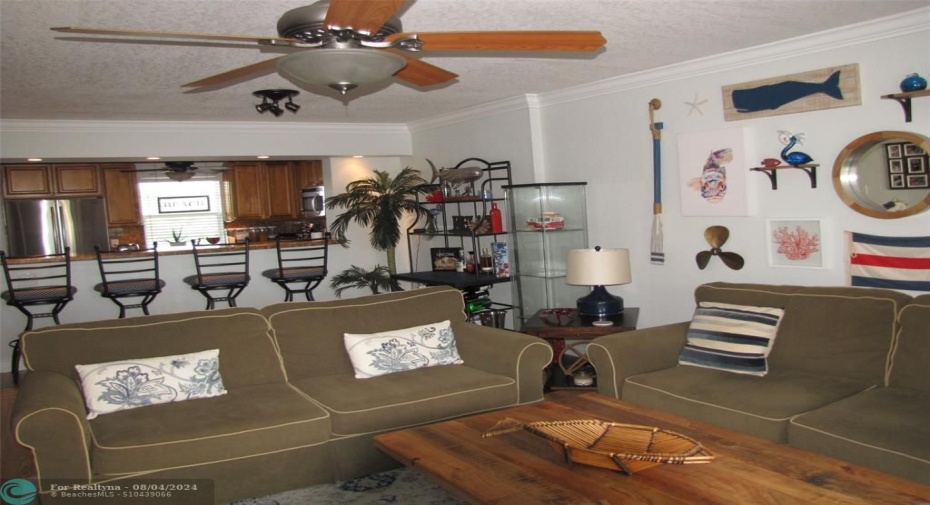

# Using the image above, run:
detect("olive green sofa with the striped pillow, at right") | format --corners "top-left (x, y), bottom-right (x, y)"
top-left (588, 283), bottom-right (930, 484)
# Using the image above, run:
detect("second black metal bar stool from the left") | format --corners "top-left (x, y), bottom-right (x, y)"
top-left (94, 242), bottom-right (165, 319)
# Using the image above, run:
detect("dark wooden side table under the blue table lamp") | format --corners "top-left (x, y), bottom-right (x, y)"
top-left (520, 307), bottom-right (639, 390)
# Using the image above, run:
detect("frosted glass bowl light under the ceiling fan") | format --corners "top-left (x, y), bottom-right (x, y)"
top-left (278, 48), bottom-right (407, 94)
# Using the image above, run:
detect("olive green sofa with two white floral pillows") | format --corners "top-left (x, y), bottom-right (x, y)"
top-left (12, 287), bottom-right (552, 504)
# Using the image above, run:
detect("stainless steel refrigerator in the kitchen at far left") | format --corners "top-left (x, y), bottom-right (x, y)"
top-left (4, 198), bottom-right (109, 256)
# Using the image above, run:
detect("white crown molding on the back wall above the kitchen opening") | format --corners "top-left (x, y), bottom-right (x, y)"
top-left (0, 119), bottom-right (410, 134)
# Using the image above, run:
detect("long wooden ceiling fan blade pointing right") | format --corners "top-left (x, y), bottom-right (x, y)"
top-left (385, 31), bottom-right (607, 51)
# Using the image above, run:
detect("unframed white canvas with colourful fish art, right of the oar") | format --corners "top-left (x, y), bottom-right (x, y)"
top-left (678, 128), bottom-right (749, 216)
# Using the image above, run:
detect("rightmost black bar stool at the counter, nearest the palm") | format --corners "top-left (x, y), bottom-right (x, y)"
top-left (262, 234), bottom-right (329, 302)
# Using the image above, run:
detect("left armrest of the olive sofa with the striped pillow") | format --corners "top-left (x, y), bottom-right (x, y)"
top-left (588, 322), bottom-right (690, 399)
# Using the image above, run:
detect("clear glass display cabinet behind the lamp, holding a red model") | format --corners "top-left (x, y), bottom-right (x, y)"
top-left (504, 182), bottom-right (589, 328)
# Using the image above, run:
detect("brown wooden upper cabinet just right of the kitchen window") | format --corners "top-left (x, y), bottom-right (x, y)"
top-left (227, 162), bottom-right (300, 220)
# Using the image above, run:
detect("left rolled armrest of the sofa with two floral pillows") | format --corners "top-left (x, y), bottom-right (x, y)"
top-left (12, 371), bottom-right (92, 490)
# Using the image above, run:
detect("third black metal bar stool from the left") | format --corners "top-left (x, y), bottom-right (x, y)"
top-left (184, 239), bottom-right (251, 310)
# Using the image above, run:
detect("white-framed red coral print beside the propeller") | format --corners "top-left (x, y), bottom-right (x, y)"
top-left (766, 219), bottom-right (823, 268)
